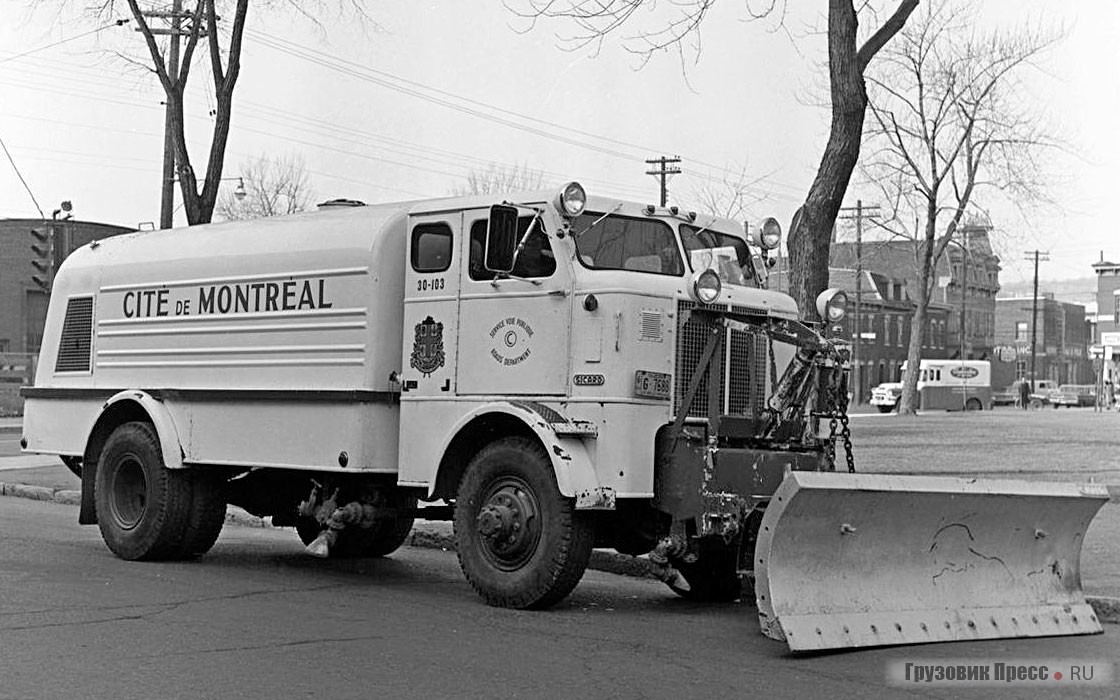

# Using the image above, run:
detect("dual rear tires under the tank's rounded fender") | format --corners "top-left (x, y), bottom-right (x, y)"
top-left (94, 422), bottom-right (225, 560)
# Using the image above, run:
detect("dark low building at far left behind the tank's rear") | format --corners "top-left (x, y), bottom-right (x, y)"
top-left (0, 218), bottom-right (132, 353)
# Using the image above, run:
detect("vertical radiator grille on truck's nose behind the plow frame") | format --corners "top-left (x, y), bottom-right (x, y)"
top-left (673, 301), bottom-right (767, 418)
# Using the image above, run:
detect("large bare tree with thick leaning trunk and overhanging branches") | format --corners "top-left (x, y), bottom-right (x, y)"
top-left (519, 0), bottom-right (918, 319)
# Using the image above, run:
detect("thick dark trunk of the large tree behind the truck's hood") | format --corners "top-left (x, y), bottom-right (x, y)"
top-left (788, 0), bottom-right (867, 320)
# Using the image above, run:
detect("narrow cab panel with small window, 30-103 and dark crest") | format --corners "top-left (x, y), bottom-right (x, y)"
top-left (401, 212), bottom-right (461, 396)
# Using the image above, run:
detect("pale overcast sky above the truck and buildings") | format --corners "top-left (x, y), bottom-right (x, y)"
top-left (0, 0), bottom-right (1120, 291)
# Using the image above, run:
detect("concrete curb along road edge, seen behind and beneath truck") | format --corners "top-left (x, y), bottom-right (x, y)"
top-left (0, 482), bottom-right (1120, 624)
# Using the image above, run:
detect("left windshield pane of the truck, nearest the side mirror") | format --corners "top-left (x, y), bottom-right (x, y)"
top-left (571, 212), bottom-right (684, 277)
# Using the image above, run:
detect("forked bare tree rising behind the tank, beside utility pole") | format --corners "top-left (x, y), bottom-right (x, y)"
top-left (32, 0), bottom-right (367, 225)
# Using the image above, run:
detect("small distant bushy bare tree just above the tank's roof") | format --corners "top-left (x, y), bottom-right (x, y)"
top-left (216, 156), bottom-right (314, 221)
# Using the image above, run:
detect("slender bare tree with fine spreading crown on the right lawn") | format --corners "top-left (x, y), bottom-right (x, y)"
top-left (862, 4), bottom-right (1060, 413)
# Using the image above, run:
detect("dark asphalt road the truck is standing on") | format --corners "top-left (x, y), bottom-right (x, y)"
top-left (0, 498), bottom-right (1120, 700)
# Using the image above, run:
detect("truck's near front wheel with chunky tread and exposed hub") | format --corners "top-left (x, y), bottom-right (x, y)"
top-left (455, 438), bottom-right (595, 609)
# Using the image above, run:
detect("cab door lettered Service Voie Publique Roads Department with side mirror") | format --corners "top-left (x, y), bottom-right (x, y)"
top-left (456, 204), bottom-right (572, 395)
